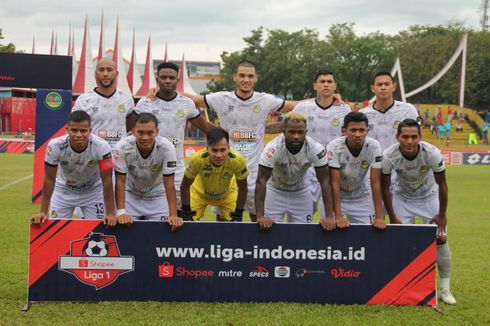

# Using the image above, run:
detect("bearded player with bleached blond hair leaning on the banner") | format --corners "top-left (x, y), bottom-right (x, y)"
top-left (255, 112), bottom-right (348, 230)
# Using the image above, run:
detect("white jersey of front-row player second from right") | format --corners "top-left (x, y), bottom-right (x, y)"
top-left (327, 136), bottom-right (383, 200)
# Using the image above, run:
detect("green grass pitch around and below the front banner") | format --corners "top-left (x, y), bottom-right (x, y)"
top-left (0, 154), bottom-right (490, 325)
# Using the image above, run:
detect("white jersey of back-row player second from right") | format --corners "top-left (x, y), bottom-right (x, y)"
top-left (293, 99), bottom-right (351, 148)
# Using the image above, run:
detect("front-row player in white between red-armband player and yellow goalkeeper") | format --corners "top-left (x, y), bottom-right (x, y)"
top-left (113, 113), bottom-right (183, 230)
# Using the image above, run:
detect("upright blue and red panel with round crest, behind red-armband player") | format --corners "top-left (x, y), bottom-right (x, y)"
top-left (32, 89), bottom-right (71, 203)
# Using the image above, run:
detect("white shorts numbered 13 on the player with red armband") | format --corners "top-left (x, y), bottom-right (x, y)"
top-left (49, 187), bottom-right (105, 220)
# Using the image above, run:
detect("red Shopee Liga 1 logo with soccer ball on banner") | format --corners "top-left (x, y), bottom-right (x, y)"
top-left (58, 233), bottom-right (134, 290)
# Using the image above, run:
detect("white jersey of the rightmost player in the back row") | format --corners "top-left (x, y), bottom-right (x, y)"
top-left (360, 101), bottom-right (418, 150)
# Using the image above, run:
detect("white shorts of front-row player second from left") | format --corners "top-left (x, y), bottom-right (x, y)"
top-left (126, 191), bottom-right (168, 221)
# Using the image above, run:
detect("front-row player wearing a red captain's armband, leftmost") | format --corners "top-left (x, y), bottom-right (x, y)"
top-left (31, 111), bottom-right (117, 226)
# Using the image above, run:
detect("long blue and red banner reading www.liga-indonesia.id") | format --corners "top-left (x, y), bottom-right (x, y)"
top-left (28, 220), bottom-right (436, 305)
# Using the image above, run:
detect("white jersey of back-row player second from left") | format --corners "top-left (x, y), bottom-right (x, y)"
top-left (135, 94), bottom-right (200, 166)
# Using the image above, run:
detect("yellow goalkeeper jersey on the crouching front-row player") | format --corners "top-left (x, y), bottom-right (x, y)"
top-left (185, 148), bottom-right (249, 199)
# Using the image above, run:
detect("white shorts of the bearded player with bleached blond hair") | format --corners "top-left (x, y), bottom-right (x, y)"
top-left (264, 186), bottom-right (313, 223)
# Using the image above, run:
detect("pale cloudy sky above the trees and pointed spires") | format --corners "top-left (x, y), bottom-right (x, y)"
top-left (0, 0), bottom-right (482, 63)
